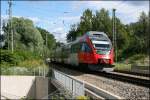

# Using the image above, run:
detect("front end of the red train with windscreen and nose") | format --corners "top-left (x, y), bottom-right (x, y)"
top-left (89, 32), bottom-right (114, 71)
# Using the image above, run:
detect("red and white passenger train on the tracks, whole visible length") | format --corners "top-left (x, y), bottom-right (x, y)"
top-left (51, 31), bottom-right (114, 71)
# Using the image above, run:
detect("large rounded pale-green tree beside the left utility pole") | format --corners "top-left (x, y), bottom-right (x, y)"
top-left (3, 17), bottom-right (43, 53)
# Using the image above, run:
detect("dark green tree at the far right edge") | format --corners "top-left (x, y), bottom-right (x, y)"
top-left (127, 12), bottom-right (149, 53)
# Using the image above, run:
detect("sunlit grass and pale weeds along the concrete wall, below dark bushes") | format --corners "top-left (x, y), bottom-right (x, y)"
top-left (1, 59), bottom-right (48, 75)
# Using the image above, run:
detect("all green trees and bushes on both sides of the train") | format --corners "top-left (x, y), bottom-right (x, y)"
top-left (0, 9), bottom-right (150, 74)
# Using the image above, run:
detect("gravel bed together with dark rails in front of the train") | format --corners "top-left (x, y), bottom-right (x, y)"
top-left (49, 65), bottom-right (149, 100)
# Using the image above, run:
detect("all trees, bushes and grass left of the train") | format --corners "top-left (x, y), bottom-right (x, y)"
top-left (0, 17), bottom-right (56, 75)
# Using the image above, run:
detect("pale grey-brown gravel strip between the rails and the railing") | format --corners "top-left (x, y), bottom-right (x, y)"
top-left (53, 67), bottom-right (150, 100)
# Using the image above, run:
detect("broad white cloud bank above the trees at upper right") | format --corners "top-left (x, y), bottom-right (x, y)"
top-left (71, 1), bottom-right (149, 24)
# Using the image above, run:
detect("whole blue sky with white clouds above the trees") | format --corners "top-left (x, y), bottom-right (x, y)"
top-left (1, 0), bottom-right (149, 43)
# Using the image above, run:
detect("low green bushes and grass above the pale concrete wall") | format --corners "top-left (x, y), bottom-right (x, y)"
top-left (0, 50), bottom-right (48, 75)
